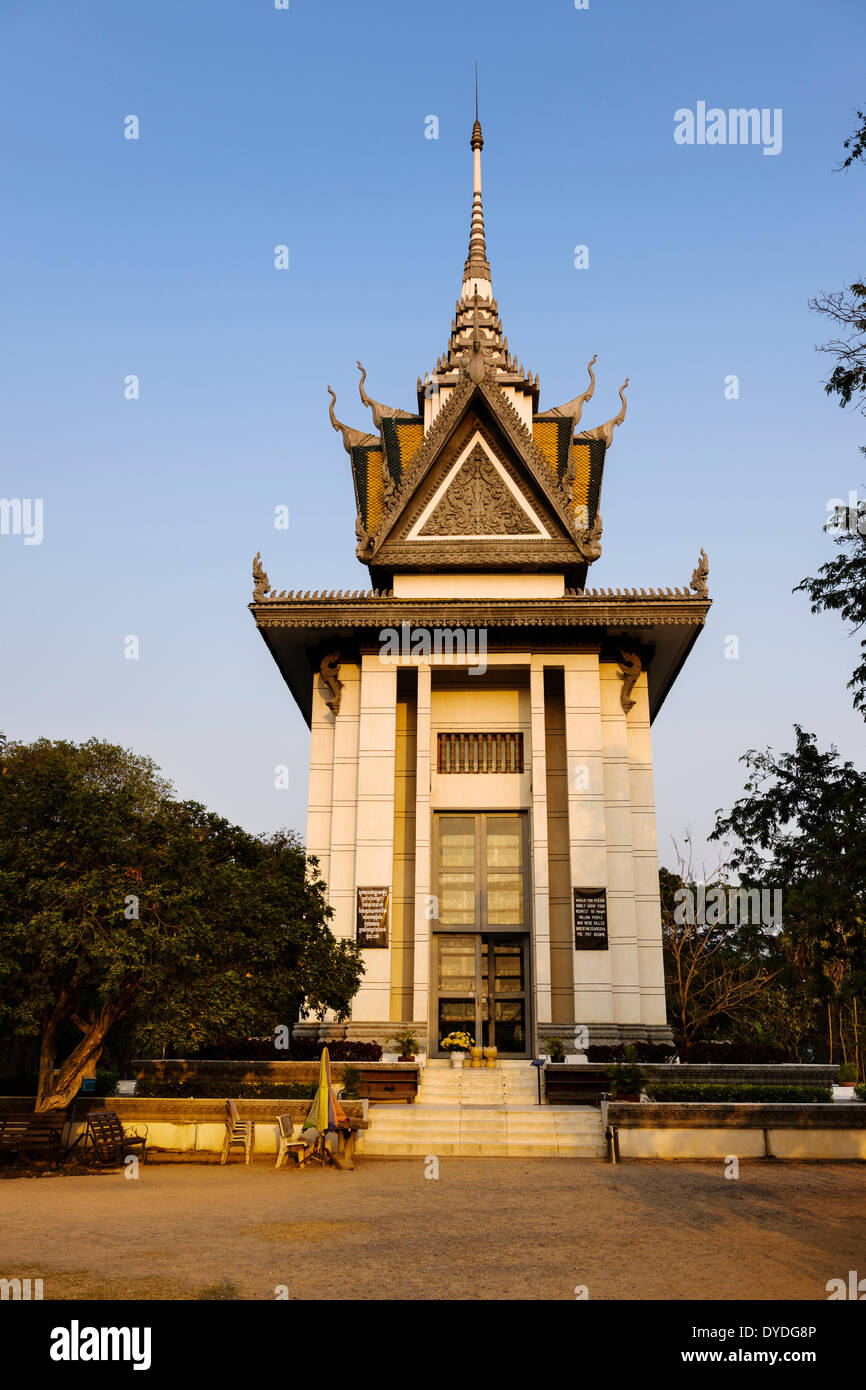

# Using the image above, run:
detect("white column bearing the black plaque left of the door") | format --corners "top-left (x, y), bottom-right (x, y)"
top-left (352, 652), bottom-right (398, 1024)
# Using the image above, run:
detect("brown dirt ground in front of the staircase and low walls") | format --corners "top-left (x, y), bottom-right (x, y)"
top-left (0, 1158), bottom-right (866, 1300)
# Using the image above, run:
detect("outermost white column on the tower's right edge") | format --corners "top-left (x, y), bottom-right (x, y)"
top-left (628, 674), bottom-right (667, 1024)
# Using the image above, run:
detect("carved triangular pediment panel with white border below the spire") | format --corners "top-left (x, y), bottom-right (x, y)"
top-left (406, 430), bottom-right (550, 541)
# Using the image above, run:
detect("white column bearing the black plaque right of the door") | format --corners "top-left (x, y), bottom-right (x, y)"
top-left (563, 652), bottom-right (614, 1024)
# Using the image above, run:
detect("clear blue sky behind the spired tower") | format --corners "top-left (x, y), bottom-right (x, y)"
top-left (0, 0), bottom-right (866, 862)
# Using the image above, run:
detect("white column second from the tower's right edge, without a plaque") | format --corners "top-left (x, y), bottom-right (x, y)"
top-left (601, 663), bottom-right (641, 1023)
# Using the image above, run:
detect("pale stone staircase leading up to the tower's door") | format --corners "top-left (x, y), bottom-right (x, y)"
top-left (356, 1061), bottom-right (606, 1159)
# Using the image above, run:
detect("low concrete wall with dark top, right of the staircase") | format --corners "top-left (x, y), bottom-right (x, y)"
top-left (607, 1101), bottom-right (866, 1161)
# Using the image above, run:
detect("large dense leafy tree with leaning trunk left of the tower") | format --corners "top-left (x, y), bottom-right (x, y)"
top-left (0, 739), bottom-right (363, 1111)
